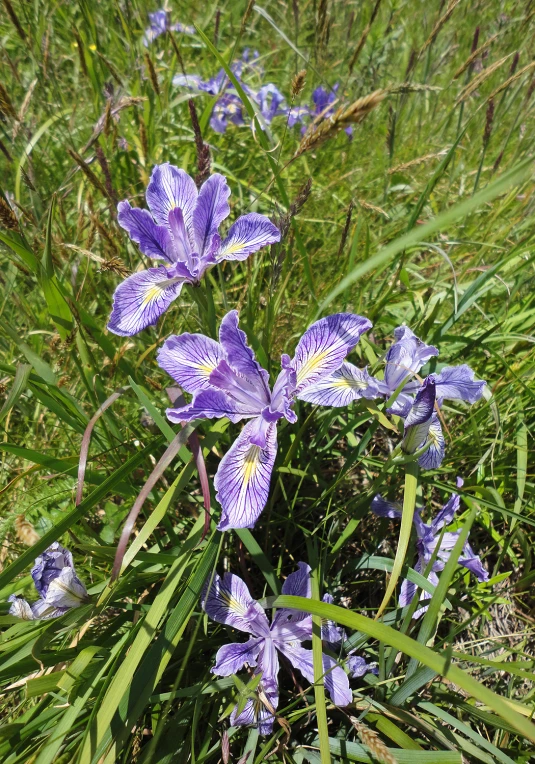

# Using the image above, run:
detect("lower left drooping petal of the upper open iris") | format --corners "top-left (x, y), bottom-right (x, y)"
top-left (108, 266), bottom-right (184, 337)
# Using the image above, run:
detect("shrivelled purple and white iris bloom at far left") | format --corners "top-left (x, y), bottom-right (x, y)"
top-left (9, 541), bottom-right (89, 620)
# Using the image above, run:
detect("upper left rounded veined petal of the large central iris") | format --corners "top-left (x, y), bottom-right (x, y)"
top-left (156, 332), bottom-right (225, 393)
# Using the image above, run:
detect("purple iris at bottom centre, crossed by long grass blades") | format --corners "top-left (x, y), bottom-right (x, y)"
top-left (202, 562), bottom-right (353, 735)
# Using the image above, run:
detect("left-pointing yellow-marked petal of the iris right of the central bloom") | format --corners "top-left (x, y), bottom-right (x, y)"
top-left (299, 361), bottom-right (381, 407)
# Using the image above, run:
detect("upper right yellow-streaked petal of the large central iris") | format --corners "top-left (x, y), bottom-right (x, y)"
top-left (292, 313), bottom-right (372, 398)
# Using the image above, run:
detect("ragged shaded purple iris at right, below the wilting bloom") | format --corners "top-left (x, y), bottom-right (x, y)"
top-left (371, 480), bottom-right (489, 618)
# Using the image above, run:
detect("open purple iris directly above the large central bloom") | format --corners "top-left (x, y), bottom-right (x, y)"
top-left (108, 162), bottom-right (280, 337)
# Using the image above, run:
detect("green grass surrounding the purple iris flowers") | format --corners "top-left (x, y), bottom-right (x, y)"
top-left (0, 0), bottom-right (535, 764)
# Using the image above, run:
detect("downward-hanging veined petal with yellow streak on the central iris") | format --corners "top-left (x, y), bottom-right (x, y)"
top-left (214, 422), bottom-right (277, 531)
